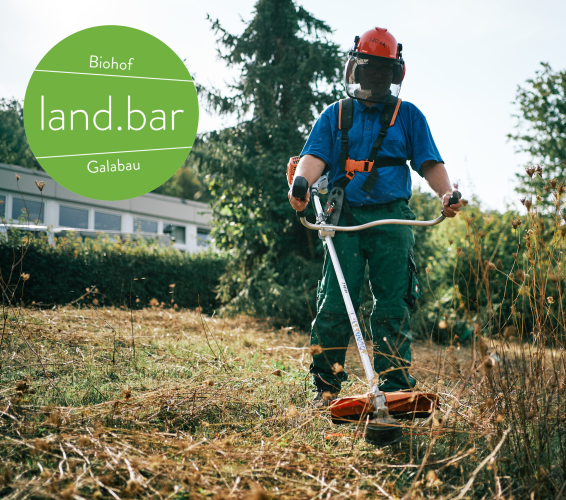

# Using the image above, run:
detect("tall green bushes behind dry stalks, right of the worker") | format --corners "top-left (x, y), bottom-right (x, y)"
top-left (404, 171), bottom-right (566, 342)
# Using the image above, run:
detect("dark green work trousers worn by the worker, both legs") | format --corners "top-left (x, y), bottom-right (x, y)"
top-left (310, 200), bottom-right (420, 393)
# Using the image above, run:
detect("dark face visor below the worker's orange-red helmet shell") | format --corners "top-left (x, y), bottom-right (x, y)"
top-left (344, 54), bottom-right (403, 103)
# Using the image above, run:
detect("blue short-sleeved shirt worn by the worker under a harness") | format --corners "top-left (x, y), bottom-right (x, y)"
top-left (301, 100), bottom-right (444, 206)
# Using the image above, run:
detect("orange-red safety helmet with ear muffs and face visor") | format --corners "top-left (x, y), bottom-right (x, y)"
top-left (344, 28), bottom-right (405, 102)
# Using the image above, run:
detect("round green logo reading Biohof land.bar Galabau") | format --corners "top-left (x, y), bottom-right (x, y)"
top-left (24, 26), bottom-right (198, 200)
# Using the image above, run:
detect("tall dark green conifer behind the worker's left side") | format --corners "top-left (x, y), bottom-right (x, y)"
top-left (193, 0), bottom-right (343, 325)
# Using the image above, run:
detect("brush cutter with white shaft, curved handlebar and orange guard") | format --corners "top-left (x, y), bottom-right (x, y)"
top-left (292, 175), bottom-right (461, 446)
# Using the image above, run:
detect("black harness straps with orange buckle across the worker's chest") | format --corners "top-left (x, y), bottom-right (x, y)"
top-left (338, 96), bottom-right (407, 194)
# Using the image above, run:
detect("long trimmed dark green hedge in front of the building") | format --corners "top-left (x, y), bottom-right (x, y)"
top-left (0, 232), bottom-right (226, 312)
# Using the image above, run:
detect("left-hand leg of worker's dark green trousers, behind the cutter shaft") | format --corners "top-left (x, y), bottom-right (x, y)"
top-left (310, 217), bottom-right (365, 393)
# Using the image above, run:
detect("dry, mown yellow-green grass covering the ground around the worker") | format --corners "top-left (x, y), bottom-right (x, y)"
top-left (0, 307), bottom-right (561, 499)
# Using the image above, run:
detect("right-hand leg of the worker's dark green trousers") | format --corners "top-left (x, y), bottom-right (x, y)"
top-left (361, 202), bottom-right (422, 392)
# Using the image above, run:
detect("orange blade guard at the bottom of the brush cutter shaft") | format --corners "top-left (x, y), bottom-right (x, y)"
top-left (330, 392), bottom-right (440, 424)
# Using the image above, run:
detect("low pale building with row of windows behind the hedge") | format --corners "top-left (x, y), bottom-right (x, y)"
top-left (0, 163), bottom-right (211, 252)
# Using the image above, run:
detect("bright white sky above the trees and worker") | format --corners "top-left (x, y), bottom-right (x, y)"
top-left (0, 0), bottom-right (566, 210)
